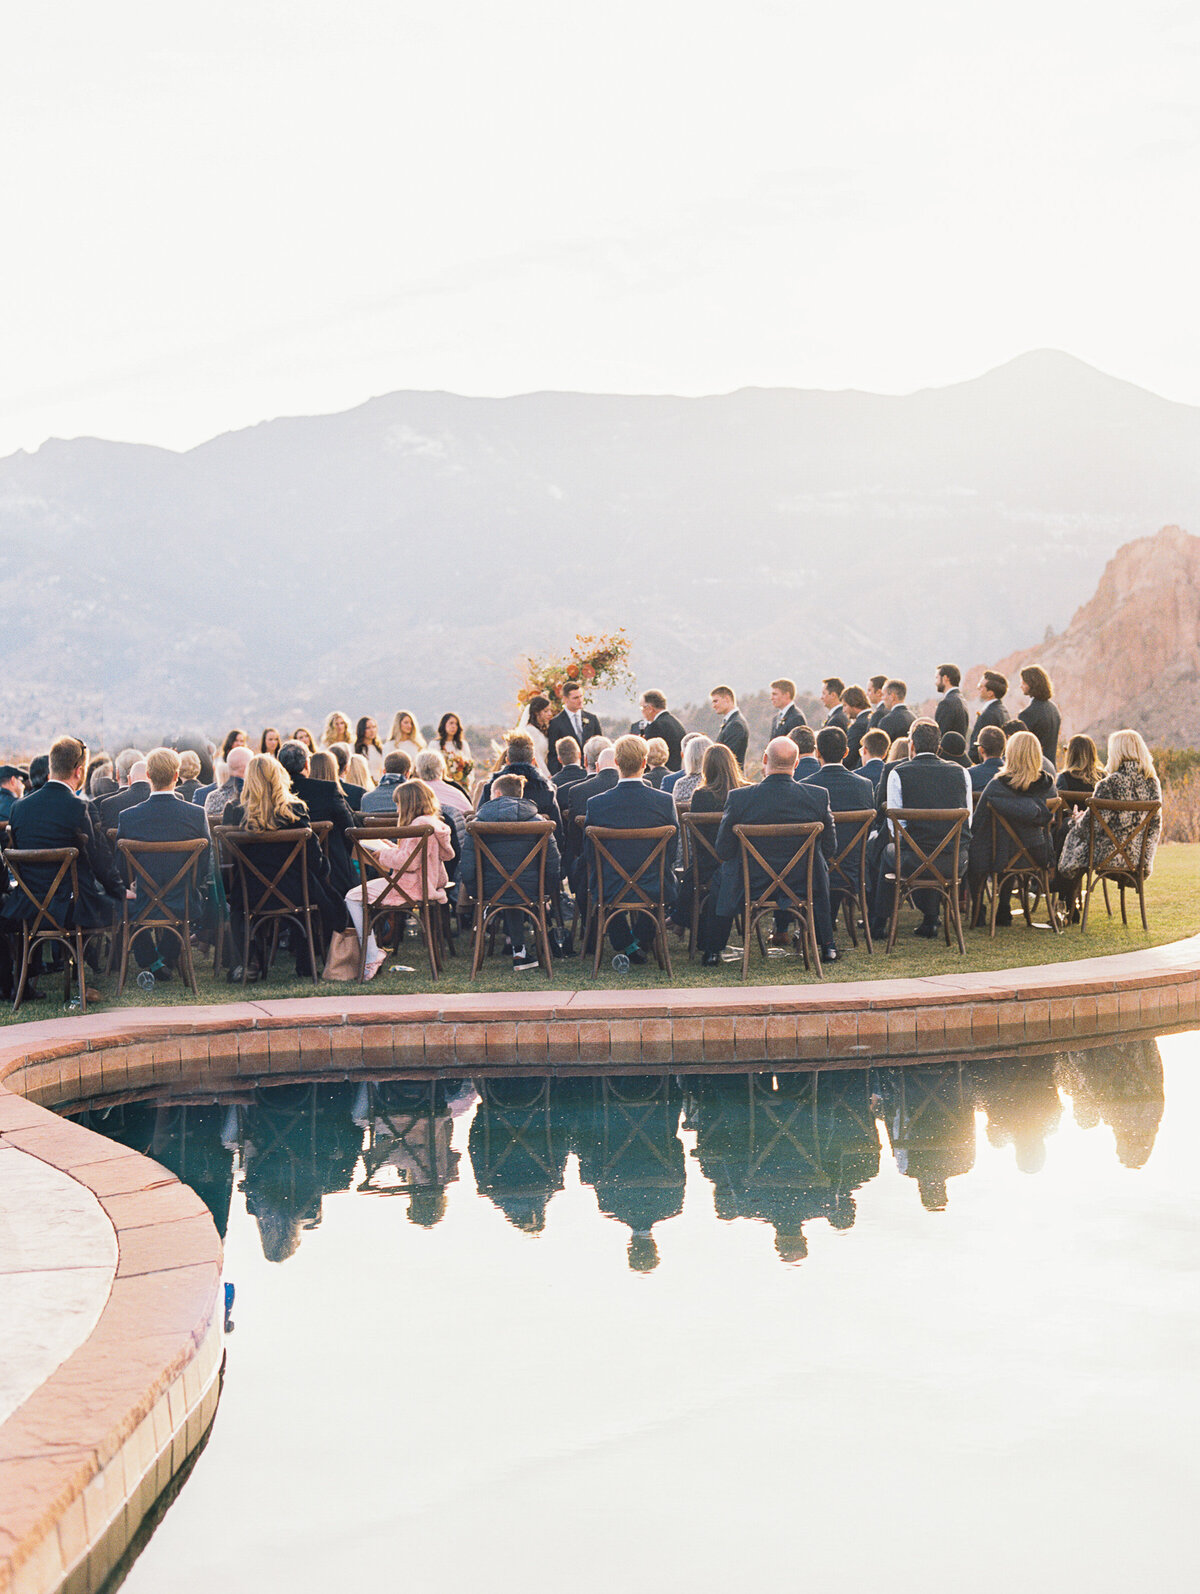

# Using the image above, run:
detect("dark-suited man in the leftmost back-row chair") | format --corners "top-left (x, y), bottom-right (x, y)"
top-left (3, 736), bottom-right (124, 999)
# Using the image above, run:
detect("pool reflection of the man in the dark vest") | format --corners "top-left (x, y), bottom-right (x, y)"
top-left (878, 1063), bottom-right (975, 1211)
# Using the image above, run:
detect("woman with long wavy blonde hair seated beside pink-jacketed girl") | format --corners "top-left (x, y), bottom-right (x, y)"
top-left (222, 743), bottom-right (349, 982)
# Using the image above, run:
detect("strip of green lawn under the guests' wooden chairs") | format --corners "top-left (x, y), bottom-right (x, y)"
top-left (0, 843), bottom-right (1200, 1025)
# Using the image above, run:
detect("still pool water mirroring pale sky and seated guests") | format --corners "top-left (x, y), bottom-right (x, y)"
top-left (77, 1036), bottom-right (1197, 1591)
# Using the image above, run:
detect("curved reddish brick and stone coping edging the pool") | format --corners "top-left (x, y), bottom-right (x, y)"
top-left (0, 936), bottom-right (1200, 1594)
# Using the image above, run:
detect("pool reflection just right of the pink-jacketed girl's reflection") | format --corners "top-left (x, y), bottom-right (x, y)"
top-left (467, 1078), bottom-right (571, 1234)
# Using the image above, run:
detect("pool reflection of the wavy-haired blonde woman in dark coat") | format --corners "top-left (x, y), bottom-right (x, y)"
top-left (239, 1084), bottom-right (362, 1262)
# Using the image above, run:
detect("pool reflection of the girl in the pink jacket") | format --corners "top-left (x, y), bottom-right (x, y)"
top-left (354, 1079), bottom-right (475, 1229)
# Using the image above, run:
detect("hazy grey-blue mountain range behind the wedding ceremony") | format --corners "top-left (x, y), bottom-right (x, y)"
top-left (0, 351), bottom-right (1200, 748)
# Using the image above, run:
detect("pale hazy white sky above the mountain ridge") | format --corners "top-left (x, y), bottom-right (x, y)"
top-left (0, 0), bottom-right (1200, 454)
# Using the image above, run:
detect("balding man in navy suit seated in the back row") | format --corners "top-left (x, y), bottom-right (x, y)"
top-left (714, 727), bottom-right (837, 963)
